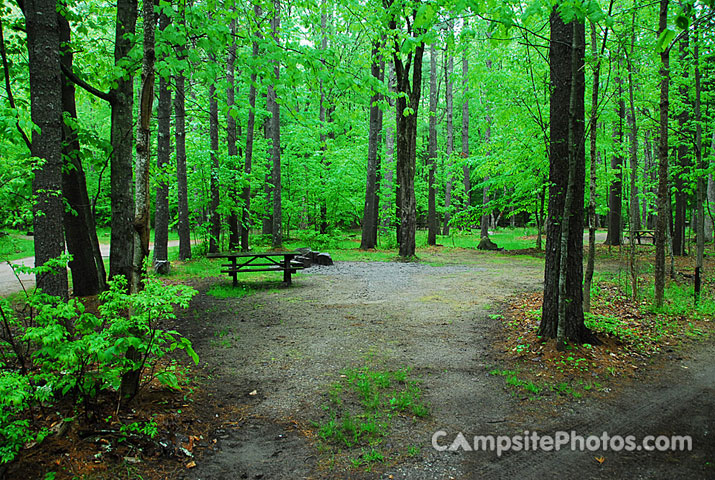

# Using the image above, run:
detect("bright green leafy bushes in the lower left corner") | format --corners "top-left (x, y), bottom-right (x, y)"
top-left (0, 269), bottom-right (198, 462)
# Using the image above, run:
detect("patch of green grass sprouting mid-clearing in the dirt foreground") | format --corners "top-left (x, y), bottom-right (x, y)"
top-left (313, 366), bottom-right (430, 470)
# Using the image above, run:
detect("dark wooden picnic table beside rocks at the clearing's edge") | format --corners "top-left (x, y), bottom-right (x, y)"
top-left (207, 252), bottom-right (304, 287)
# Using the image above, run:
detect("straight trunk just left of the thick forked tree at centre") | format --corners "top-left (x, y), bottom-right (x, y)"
top-left (360, 42), bottom-right (385, 250)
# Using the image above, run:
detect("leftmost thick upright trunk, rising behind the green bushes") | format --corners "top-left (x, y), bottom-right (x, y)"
top-left (24, 0), bottom-right (68, 298)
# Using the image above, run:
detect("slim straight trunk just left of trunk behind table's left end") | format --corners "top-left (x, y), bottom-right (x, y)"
top-left (174, 72), bottom-right (191, 260)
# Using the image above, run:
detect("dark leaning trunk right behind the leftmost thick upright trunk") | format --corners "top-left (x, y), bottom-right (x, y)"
top-left (57, 14), bottom-right (106, 297)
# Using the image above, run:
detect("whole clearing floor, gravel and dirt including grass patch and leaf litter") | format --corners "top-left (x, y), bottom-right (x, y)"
top-left (5, 244), bottom-right (715, 480)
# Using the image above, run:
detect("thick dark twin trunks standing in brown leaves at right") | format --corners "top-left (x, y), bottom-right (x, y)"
top-left (539, 9), bottom-right (597, 342)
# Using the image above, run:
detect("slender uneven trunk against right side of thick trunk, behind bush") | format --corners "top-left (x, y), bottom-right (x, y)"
top-left (134, 1), bottom-right (155, 292)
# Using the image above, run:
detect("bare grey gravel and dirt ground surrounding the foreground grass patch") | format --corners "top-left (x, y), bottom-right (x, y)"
top-left (179, 252), bottom-right (715, 479)
